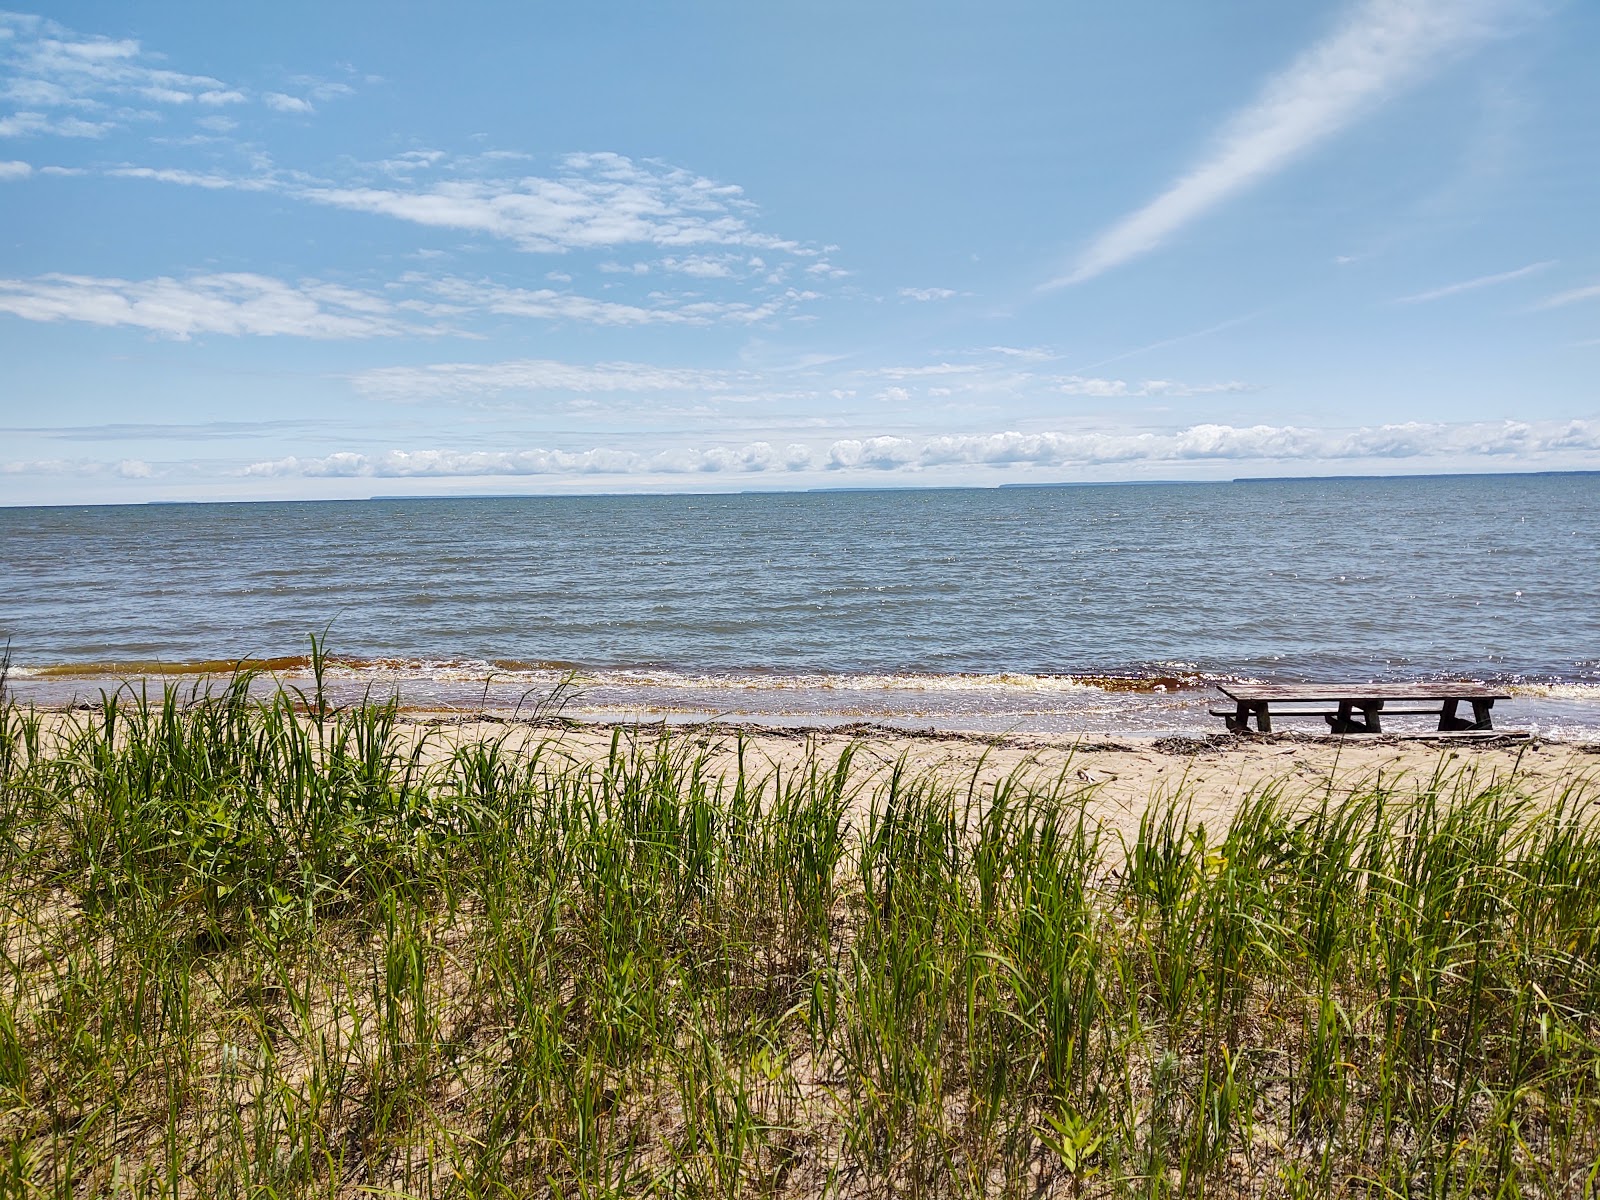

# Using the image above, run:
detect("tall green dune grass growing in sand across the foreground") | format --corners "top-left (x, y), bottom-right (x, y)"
top-left (0, 662), bottom-right (1600, 1200)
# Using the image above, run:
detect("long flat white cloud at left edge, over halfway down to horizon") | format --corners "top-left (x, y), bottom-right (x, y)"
top-left (0, 272), bottom-right (430, 341)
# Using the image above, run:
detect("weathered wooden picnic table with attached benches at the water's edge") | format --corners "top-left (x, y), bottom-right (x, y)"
top-left (1211, 682), bottom-right (1510, 733)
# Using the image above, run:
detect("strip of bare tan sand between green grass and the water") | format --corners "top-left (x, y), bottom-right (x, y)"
top-left (390, 714), bottom-right (1600, 842)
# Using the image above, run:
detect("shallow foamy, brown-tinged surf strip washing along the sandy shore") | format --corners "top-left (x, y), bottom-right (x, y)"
top-left (6, 659), bottom-right (1600, 741)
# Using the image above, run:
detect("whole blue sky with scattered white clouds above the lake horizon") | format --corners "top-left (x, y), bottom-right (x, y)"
top-left (0, 0), bottom-right (1600, 504)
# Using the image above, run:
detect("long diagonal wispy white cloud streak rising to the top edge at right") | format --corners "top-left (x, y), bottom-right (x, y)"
top-left (1045, 0), bottom-right (1509, 286)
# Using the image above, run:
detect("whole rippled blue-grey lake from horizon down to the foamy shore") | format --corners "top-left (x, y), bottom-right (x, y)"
top-left (0, 474), bottom-right (1600, 734)
